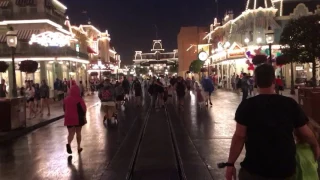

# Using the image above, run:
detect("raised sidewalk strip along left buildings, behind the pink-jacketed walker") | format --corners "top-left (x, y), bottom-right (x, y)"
top-left (0, 95), bottom-right (99, 143)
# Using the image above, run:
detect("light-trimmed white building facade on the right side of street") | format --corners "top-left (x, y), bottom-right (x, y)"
top-left (204, 0), bottom-right (320, 87)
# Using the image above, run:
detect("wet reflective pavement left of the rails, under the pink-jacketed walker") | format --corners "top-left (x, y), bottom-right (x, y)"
top-left (0, 96), bottom-right (144, 180)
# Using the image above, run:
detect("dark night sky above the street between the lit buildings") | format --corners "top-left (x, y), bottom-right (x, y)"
top-left (61, 0), bottom-right (246, 64)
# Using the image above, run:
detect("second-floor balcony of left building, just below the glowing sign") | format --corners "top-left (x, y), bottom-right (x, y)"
top-left (0, 42), bottom-right (89, 60)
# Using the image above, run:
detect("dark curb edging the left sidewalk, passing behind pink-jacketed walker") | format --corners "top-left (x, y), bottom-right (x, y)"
top-left (0, 102), bottom-right (99, 144)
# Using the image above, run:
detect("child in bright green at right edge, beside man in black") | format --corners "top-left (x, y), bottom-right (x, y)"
top-left (295, 119), bottom-right (320, 180)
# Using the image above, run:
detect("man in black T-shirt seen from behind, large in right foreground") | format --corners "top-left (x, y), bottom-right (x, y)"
top-left (224, 64), bottom-right (320, 180)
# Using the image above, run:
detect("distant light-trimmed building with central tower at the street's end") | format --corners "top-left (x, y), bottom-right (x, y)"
top-left (133, 40), bottom-right (179, 75)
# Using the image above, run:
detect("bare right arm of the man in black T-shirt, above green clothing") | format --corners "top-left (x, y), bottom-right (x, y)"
top-left (296, 125), bottom-right (319, 160)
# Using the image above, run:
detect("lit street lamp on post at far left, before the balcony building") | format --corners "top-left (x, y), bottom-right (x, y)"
top-left (6, 27), bottom-right (18, 97)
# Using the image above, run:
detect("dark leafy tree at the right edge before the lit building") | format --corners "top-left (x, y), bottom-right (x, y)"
top-left (280, 15), bottom-right (320, 88)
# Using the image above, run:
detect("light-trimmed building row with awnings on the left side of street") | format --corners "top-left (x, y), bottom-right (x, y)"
top-left (0, 0), bottom-right (121, 95)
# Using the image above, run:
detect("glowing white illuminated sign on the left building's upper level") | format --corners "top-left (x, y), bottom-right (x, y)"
top-left (29, 31), bottom-right (71, 47)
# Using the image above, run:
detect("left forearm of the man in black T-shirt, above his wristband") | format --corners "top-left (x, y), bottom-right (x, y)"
top-left (228, 123), bottom-right (247, 164)
